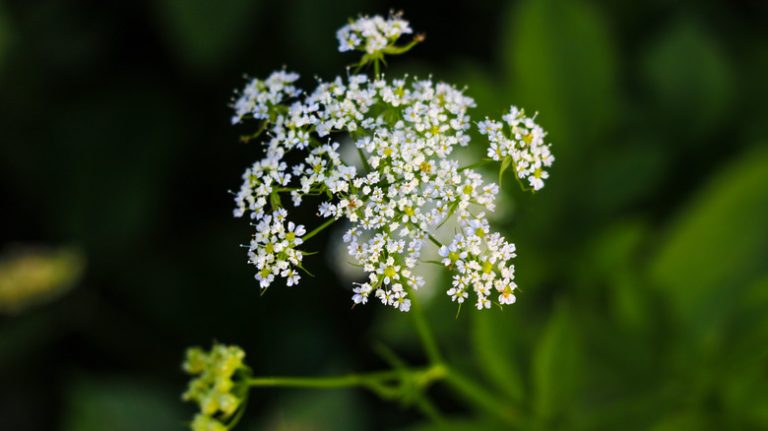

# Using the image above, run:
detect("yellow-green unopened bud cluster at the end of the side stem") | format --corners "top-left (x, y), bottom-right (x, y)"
top-left (182, 344), bottom-right (245, 431)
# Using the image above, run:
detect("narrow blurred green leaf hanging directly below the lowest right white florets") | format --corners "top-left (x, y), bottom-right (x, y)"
top-left (472, 310), bottom-right (524, 401)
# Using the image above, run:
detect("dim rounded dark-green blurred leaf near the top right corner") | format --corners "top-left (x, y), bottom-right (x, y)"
top-left (644, 21), bottom-right (733, 138)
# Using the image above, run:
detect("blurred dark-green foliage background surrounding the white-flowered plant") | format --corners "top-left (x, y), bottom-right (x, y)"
top-left (0, 0), bottom-right (768, 431)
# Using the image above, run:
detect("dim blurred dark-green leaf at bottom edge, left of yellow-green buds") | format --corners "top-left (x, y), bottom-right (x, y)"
top-left (61, 378), bottom-right (183, 431)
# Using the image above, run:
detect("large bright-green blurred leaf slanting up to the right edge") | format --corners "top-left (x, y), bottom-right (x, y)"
top-left (650, 147), bottom-right (768, 342)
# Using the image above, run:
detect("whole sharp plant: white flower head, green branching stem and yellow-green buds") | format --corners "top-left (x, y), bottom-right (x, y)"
top-left (183, 10), bottom-right (554, 431)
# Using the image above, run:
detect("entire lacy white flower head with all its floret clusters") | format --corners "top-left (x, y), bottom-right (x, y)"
top-left (232, 11), bottom-right (554, 311)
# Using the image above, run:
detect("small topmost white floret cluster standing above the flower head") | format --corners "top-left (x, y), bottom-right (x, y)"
top-left (336, 14), bottom-right (412, 54)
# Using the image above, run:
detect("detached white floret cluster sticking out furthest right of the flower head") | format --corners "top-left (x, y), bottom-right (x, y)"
top-left (478, 106), bottom-right (555, 190)
